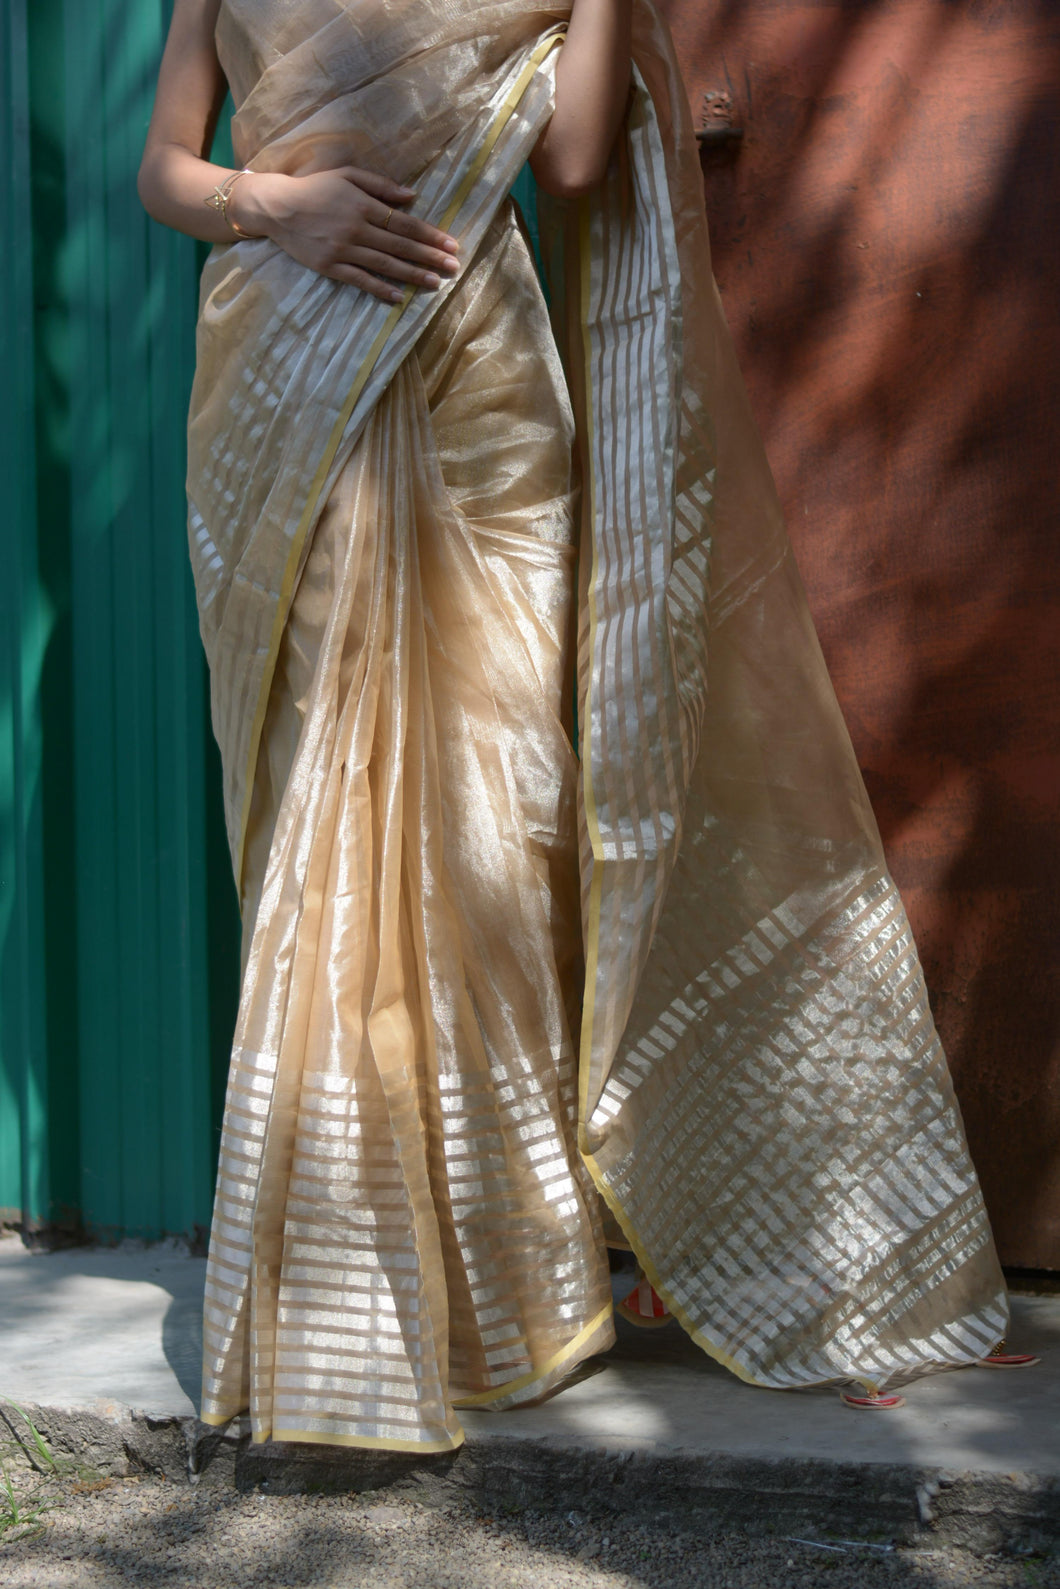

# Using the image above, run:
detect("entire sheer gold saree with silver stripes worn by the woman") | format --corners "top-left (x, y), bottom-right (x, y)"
top-left (189, 0), bottom-right (1006, 1451)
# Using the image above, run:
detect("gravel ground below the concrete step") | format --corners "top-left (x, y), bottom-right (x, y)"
top-left (0, 1476), bottom-right (1060, 1589)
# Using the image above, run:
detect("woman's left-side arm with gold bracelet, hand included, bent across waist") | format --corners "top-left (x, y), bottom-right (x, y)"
top-left (137, 0), bottom-right (459, 303)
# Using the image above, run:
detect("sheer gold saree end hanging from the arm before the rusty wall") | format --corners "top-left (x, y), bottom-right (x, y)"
top-left (542, 6), bottom-right (1008, 1386)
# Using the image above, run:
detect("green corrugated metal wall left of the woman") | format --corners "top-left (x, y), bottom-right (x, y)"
top-left (0, 0), bottom-right (237, 1236)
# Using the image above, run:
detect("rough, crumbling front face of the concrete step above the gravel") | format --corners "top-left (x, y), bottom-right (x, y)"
top-left (14, 1401), bottom-right (1060, 1552)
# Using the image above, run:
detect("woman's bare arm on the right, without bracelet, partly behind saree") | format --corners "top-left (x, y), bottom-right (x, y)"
top-left (531, 0), bottom-right (633, 199)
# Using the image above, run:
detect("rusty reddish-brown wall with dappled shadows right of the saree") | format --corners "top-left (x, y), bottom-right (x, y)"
top-left (663, 0), bottom-right (1060, 1270)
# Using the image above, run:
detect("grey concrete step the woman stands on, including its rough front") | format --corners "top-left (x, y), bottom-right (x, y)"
top-left (0, 1239), bottom-right (1060, 1549)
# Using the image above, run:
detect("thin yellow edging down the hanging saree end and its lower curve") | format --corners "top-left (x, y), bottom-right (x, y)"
top-left (578, 199), bottom-right (879, 1394)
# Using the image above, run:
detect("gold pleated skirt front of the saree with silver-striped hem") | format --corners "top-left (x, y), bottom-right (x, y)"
top-left (203, 192), bottom-right (610, 1449)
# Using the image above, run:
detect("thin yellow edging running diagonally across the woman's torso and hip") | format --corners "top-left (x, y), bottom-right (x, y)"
top-left (235, 29), bottom-right (564, 903)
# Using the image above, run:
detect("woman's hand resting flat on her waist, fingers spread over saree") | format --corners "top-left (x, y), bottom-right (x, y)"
top-left (227, 165), bottom-right (459, 303)
